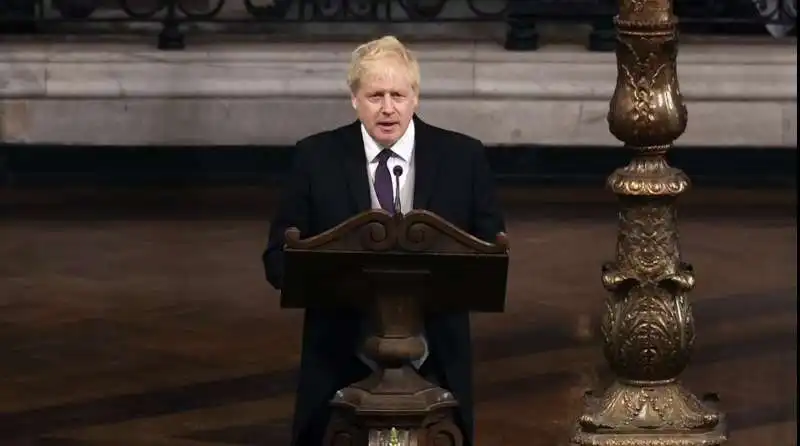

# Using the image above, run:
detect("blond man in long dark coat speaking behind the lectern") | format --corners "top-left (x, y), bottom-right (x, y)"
top-left (263, 37), bottom-right (504, 446)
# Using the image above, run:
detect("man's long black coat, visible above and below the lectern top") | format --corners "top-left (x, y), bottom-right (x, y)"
top-left (263, 117), bottom-right (505, 446)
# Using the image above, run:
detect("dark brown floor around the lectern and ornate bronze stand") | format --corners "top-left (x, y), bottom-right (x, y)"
top-left (0, 186), bottom-right (797, 446)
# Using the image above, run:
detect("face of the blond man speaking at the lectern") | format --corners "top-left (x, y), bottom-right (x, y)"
top-left (352, 61), bottom-right (418, 147)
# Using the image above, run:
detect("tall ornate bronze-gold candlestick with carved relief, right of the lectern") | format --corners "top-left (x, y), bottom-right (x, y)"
top-left (572, 0), bottom-right (727, 446)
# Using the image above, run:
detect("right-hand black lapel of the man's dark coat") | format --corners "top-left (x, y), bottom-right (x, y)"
top-left (414, 116), bottom-right (440, 209)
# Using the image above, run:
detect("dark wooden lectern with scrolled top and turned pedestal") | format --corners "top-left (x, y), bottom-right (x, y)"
top-left (281, 210), bottom-right (508, 446)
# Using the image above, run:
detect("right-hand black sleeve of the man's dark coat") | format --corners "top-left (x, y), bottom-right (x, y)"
top-left (471, 141), bottom-right (506, 243)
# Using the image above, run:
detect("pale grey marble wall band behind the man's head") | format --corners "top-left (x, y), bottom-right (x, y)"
top-left (0, 42), bottom-right (797, 147)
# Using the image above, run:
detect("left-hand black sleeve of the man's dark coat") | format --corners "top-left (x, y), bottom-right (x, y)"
top-left (261, 141), bottom-right (311, 290)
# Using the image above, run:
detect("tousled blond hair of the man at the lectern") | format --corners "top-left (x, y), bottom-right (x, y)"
top-left (347, 36), bottom-right (420, 93)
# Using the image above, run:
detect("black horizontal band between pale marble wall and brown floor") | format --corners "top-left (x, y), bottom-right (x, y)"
top-left (0, 145), bottom-right (797, 188)
